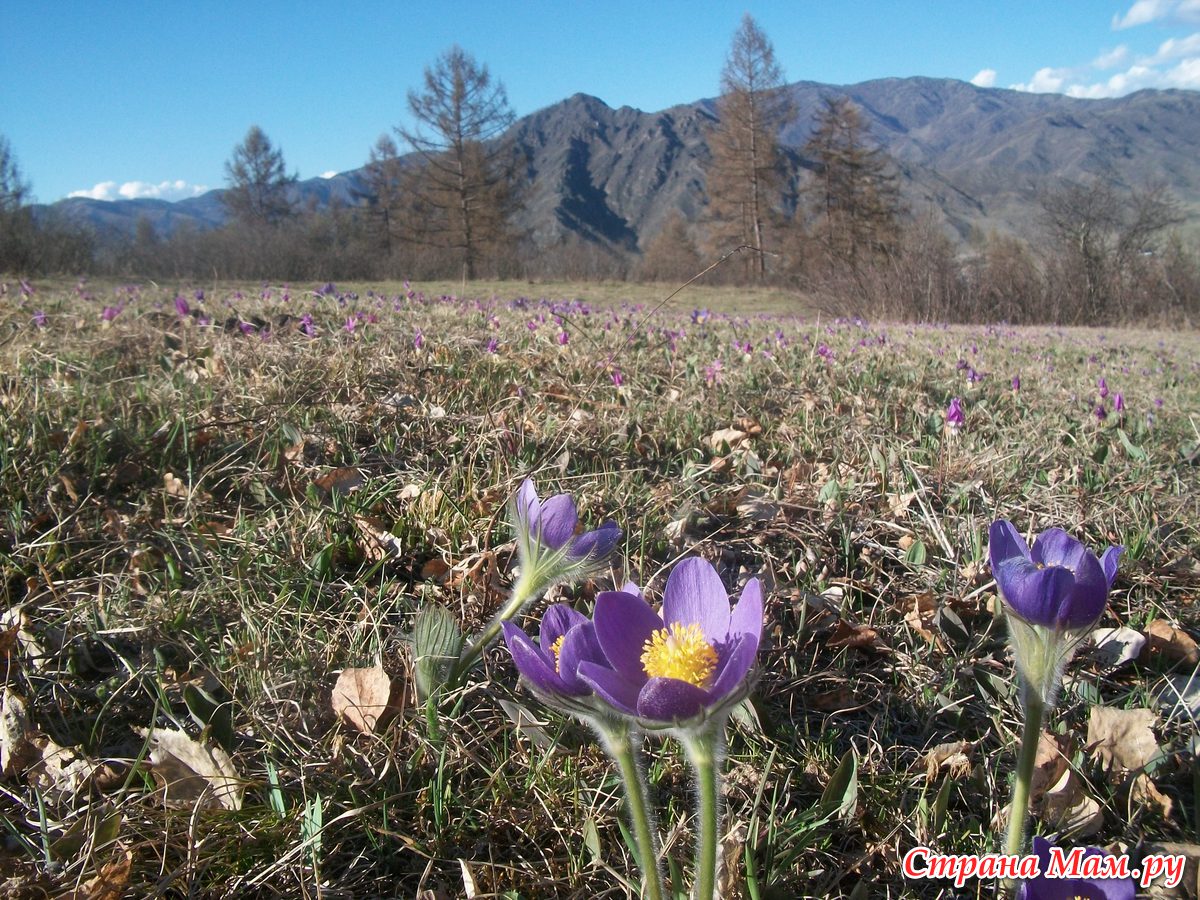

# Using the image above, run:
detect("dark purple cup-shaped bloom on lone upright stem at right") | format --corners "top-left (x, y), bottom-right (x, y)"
top-left (988, 520), bottom-right (1124, 631)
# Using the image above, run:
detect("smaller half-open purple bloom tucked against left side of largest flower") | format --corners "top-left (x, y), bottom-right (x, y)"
top-left (502, 604), bottom-right (606, 706)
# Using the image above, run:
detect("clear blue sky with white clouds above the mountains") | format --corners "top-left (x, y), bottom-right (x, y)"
top-left (0, 0), bottom-right (1200, 203)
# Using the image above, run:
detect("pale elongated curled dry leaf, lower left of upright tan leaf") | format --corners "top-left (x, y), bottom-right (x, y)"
top-left (138, 728), bottom-right (242, 811)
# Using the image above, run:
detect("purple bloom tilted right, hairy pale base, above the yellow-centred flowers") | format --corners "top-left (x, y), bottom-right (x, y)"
top-left (512, 478), bottom-right (620, 586)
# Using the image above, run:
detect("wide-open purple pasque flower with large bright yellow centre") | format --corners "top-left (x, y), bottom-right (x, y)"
top-left (578, 557), bottom-right (762, 727)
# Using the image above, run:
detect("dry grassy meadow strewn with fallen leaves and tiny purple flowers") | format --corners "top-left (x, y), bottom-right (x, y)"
top-left (0, 281), bottom-right (1200, 900)
